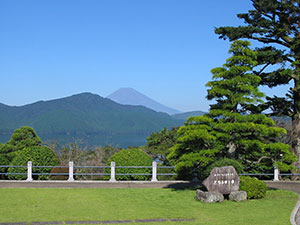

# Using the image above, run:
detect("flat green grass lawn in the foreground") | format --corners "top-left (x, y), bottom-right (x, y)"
top-left (0, 188), bottom-right (298, 225)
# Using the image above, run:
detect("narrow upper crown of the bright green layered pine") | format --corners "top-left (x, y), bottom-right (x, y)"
top-left (206, 41), bottom-right (264, 113)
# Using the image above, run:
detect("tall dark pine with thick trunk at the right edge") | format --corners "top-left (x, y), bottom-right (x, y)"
top-left (215, 0), bottom-right (300, 170)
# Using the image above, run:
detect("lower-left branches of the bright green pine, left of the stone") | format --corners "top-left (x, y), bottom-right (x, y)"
top-left (168, 116), bottom-right (218, 180)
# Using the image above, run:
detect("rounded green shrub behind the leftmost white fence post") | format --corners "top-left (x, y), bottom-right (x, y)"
top-left (8, 146), bottom-right (59, 180)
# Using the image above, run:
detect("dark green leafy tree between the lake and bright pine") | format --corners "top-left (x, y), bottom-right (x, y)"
top-left (146, 127), bottom-right (178, 165)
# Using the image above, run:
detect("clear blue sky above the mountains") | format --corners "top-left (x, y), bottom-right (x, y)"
top-left (0, 0), bottom-right (290, 111)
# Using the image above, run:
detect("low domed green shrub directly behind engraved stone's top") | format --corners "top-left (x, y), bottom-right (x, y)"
top-left (200, 158), bottom-right (244, 179)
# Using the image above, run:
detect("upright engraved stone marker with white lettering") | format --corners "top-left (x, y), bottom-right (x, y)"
top-left (203, 166), bottom-right (240, 194)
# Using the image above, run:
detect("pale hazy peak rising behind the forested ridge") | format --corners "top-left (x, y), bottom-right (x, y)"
top-left (106, 88), bottom-right (180, 115)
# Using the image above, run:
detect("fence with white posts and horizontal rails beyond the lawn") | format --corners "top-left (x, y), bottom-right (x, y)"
top-left (0, 162), bottom-right (300, 182)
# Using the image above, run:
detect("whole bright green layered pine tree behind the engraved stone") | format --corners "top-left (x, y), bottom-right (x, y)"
top-left (168, 41), bottom-right (295, 179)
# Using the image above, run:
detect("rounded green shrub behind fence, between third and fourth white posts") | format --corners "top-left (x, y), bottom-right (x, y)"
top-left (105, 148), bottom-right (152, 180)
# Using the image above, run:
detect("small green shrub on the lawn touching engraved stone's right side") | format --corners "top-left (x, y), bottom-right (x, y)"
top-left (240, 176), bottom-right (268, 199)
